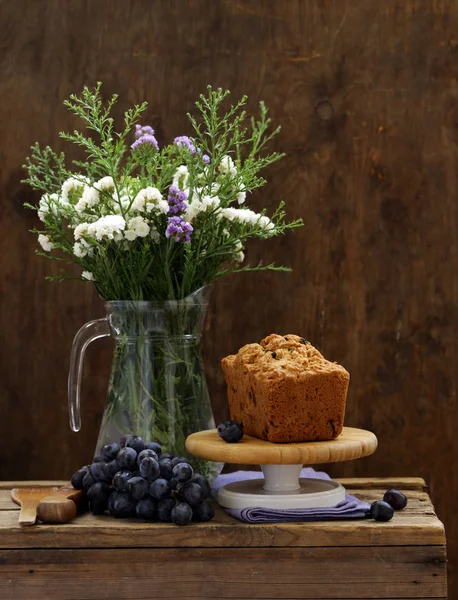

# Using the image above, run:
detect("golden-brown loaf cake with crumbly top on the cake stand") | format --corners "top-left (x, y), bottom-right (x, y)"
top-left (221, 334), bottom-right (350, 442)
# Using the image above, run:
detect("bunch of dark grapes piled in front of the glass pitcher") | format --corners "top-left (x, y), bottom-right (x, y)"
top-left (72, 435), bottom-right (214, 525)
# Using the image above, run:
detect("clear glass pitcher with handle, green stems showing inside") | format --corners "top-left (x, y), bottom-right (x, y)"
top-left (68, 286), bottom-right (221, 476)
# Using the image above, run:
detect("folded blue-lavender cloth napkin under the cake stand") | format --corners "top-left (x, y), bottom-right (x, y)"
top-left (212, 467), bottom-right (370, 523)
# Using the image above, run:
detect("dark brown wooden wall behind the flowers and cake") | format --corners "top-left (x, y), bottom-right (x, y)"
top-left (0, 0), bottom-right (458, 598)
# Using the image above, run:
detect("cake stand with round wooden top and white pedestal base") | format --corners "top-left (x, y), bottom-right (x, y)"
top-left (186, 427), bottom-right (377, 509)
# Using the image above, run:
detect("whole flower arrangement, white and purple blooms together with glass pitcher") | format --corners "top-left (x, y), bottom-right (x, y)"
top-left (25, 84), bottom-right (302, 474)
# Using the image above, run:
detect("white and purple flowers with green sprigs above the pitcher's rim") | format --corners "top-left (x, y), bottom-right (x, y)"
top-left (25, 84), bottom-right (302, 301)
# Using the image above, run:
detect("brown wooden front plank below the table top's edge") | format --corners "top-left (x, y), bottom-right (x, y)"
top-left (0, 547), bottom-right (446, 600)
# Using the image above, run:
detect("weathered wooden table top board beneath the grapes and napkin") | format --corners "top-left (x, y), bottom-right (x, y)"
top-left (0, 478), bottom-right (445, 549)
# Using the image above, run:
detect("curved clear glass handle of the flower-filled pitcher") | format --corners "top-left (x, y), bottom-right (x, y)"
top-left (68, 318), bottom-right (111, 431)
